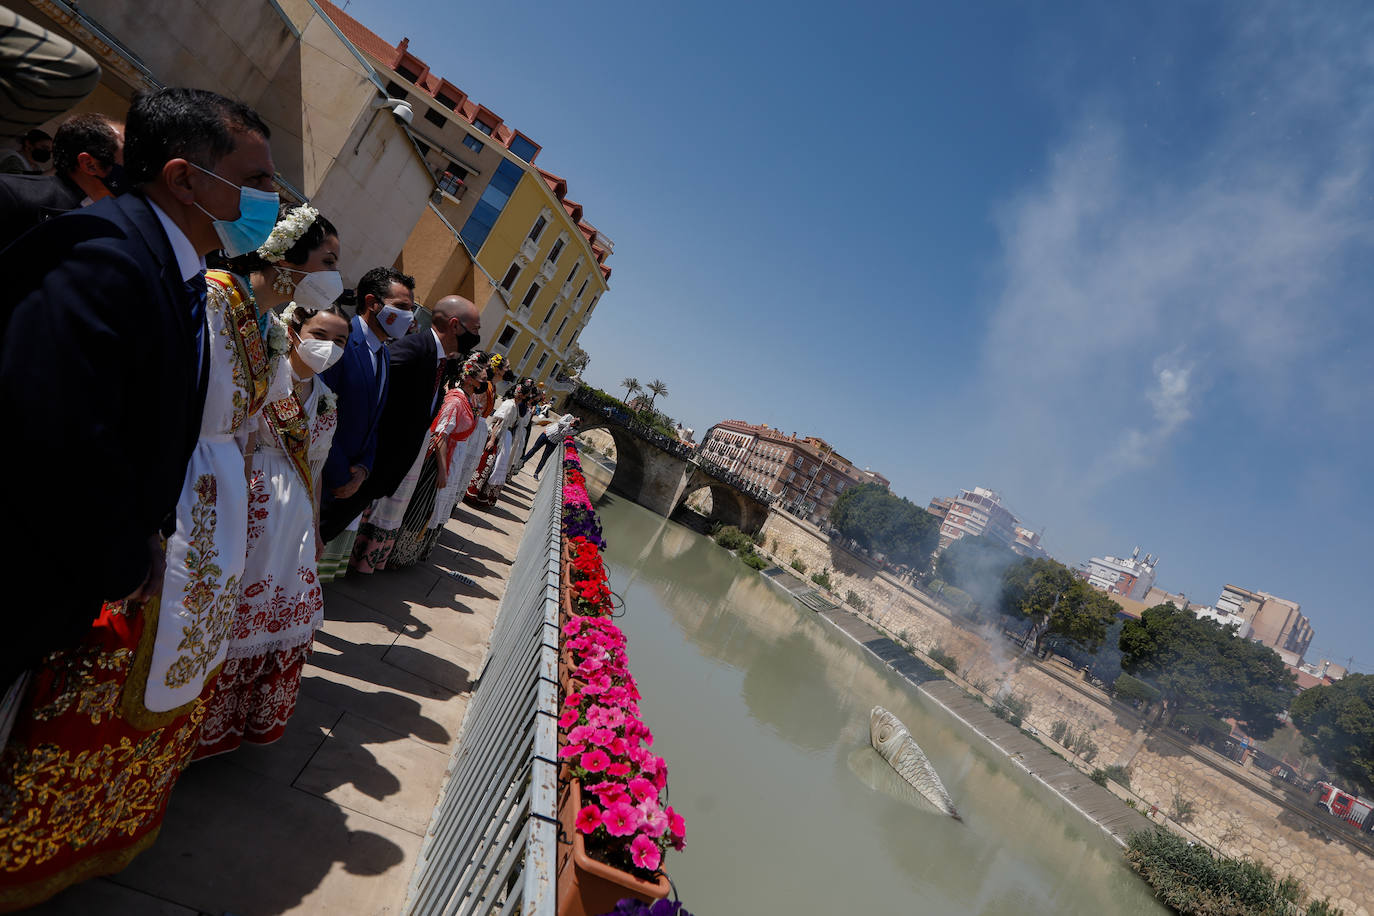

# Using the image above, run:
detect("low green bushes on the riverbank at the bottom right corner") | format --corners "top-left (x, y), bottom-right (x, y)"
top-left (1125, 829), bottom-right (1340, 916)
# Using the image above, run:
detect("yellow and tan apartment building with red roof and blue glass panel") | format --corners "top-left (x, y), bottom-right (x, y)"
top-left (319, 0), bottom-right (614, 394)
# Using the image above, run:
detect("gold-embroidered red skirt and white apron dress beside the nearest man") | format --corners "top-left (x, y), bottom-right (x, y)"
top-left (0, 271), bottom-right (278, 911)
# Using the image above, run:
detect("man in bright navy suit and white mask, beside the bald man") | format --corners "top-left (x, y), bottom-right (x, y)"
top-left (320, 268), bottom-right (415, 541)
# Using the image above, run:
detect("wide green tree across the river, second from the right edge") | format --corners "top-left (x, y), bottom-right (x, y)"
top-left (1120, 604), bottom-right (1297, 739)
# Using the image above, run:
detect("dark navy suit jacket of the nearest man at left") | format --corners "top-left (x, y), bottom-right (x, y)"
top-left (0, 195), bottom-right (210, 683)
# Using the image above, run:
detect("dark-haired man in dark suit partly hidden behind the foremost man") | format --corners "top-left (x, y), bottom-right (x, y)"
top-left (0, 114), bottom-right (124, 249)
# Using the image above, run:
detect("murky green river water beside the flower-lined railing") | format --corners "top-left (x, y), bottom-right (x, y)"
top-left (587, 461), bottom-right (1168, 916)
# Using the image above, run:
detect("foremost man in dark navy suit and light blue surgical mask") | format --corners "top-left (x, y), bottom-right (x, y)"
top-left (0, 89), bottom-right (273, 689)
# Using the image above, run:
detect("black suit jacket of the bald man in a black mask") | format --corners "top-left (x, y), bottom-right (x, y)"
top-left (365, 331), bottom-right (438, 499)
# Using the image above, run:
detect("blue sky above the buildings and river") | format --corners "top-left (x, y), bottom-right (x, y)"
top-left (349, 0), bottom-right (1374, 670)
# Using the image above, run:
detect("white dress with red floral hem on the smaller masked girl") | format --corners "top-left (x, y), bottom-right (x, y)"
top-left (194, 376), bottom-right (338, 759)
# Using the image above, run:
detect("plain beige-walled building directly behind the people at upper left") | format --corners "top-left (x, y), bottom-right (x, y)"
top-left (18, 0), bottom-right (434, 286)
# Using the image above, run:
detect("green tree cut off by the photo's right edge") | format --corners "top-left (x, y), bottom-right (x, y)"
top-left (1289, 674), bottom-right (1374, 791)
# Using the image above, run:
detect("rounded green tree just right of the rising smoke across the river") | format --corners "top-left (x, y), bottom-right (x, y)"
top-left (1000, 554), bottom-right (1117, 652)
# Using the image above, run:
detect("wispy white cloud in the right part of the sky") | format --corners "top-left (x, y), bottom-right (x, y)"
top-left (981, 4), bottom-right (1374, 502)
